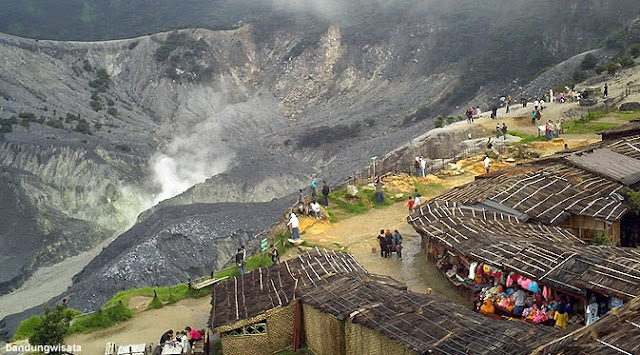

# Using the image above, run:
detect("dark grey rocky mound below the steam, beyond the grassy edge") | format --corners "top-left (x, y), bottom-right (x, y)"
top-left (66, 200), bottom-right (291, 310)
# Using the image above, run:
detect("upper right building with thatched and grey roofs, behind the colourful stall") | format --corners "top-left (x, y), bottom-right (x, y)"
top-left (417, 132), bottom-right (640, 247)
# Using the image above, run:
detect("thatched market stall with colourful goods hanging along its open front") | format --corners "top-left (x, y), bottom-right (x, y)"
top-left (408, 201), bottom-right (640, 327)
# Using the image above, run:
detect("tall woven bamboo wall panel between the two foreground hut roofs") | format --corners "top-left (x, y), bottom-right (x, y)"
top-left (302, 304), bottom-right (345, 355)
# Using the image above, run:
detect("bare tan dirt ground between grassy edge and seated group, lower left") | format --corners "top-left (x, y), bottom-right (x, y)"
top-left (65, 297), bottom-right (211, 354)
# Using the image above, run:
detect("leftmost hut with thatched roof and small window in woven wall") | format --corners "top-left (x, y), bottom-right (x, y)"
top-left (209, 248), bottom-right (367, 354)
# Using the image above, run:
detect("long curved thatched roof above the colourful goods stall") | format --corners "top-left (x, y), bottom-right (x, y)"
top-left (408, 202), bottom-right (640, 300)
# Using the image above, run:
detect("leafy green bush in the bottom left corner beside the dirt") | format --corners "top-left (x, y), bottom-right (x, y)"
top-left (29, 304), bottom-right (72, 354)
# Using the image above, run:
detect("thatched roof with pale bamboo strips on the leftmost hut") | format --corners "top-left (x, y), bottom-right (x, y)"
top-left (209, 248), bottom-right (367, 330)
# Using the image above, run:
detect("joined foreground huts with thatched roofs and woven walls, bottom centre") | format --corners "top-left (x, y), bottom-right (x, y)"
top-left (210, 249), bottom-right (554, 354)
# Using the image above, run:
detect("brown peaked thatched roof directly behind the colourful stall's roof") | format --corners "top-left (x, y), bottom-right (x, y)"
top-left (434, 162), bottom-right (627, 225)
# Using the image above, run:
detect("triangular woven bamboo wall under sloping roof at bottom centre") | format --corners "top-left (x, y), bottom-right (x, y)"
top-left (345, 321), bottom-right (416, 355)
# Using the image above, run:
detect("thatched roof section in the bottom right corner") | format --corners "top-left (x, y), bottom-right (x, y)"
top-left (531, 298), bottom-right (640, 355)
